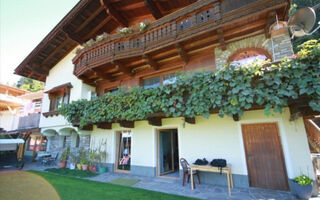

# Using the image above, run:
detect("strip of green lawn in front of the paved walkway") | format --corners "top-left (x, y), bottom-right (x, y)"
top-left (31, 171), bottom-right (198, 200)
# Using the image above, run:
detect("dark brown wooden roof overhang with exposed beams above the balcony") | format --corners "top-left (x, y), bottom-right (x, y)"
top-left (15, 0), bottom-right (196, 81)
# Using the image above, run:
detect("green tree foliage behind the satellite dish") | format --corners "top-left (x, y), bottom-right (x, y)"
top-left (290, 0), bottom-right (320, 52)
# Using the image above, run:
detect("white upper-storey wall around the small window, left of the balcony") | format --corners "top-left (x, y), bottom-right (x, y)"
top-left (39, 50), bottom-right (95, 128)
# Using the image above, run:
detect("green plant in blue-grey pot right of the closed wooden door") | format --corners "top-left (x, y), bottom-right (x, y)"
top-left (292, 174), bottom-right (313, 199)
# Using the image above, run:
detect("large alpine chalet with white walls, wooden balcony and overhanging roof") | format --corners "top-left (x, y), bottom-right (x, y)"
top-left (15, 0), bottom-right (315, 190)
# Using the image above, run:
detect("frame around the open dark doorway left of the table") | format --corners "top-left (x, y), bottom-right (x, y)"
top-left (155, 127), bottom-right (180, 179)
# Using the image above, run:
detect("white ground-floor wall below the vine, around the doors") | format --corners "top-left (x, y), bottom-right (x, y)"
top-left (91, 109), bottom-right (314, 178)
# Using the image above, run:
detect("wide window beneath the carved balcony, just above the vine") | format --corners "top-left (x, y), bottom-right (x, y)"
top-left (142, 73), bottom-right (177, 89)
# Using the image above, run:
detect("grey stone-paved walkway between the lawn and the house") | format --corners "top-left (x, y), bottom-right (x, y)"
top-left (14, 163), bottom-right (302, 200)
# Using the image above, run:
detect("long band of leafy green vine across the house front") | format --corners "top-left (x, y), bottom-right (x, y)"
top-left (59, 40), bottom-right (320, 127)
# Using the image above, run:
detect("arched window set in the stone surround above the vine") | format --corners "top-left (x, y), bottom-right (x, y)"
top-left (228, 48), bottom-right (272, 65)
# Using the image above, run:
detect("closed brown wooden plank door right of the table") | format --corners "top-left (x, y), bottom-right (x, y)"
top-left (242, 123), bottom-right (289, 190)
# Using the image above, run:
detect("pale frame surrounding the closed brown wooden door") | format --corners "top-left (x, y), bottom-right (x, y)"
top-left (240, 121), bottom-right (290, 191)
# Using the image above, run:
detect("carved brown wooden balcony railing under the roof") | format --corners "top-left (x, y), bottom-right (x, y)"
top-left (73, 0), bottom-right (221, 76)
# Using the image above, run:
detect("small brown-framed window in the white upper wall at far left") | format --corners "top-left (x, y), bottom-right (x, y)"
top-left (45, 83), bottom-right (72, 111)
